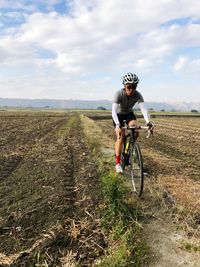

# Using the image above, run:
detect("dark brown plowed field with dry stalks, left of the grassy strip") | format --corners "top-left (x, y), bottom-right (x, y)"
top-left (0, 113), bottom-right (105, 266)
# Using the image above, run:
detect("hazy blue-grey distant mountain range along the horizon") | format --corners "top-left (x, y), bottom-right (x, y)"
top-left (0, 98), bottom-right (200, 112)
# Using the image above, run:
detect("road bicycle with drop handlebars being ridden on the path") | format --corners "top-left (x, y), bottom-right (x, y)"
top-left (121, 121), bottom-right (151, 197)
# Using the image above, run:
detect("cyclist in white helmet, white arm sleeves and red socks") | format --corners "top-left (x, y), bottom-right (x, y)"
top-left (112, 72), bottom-right (154, 173)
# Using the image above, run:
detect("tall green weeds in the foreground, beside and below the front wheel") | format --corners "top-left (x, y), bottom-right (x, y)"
top-left (97, 173), bottom-right (148, 267)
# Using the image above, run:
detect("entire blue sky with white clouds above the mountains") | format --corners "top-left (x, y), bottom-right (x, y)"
top-left (0, 0), bottom-right (200, 102)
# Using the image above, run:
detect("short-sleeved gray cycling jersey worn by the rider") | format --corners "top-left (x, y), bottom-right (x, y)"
top-left (113, 89), bottom-right (144, 114)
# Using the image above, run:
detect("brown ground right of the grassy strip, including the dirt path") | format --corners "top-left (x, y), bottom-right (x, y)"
top-left (84, 115), bottom-right (200, 267)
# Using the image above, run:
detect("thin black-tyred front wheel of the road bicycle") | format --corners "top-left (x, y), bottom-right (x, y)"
top-left (130, 142), bottom-right (144, 196)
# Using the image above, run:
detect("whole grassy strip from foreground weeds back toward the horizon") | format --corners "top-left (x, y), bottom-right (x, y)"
top-left (82, 117), bottom-right (150, 267)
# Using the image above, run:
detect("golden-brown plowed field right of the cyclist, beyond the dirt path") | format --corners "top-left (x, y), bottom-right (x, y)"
top-left (93, 116), bottom-right (200, 222)
